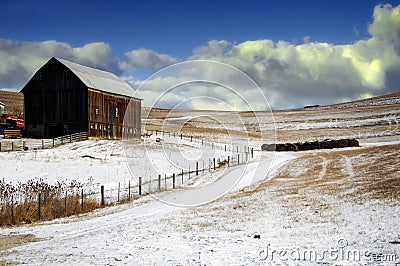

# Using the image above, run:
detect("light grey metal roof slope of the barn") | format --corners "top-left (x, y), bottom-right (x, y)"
top-left (55, 57), bottom-right (138, 97)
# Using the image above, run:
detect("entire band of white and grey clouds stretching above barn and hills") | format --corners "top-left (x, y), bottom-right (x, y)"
top-left (0, 5), bottom-right (400, 109)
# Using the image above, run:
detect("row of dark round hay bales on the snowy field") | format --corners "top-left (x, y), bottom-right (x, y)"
top-left (261, 139), bottom-right (360, 151)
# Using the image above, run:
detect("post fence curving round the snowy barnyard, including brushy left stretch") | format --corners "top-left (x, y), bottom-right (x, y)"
top-left (0, 131), bottom-right (253, 226)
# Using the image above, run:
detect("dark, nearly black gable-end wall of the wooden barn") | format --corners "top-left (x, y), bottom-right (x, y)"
top-left (23, 57), bottom-right (88, 138)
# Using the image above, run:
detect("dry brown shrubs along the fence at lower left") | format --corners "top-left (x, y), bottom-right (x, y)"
top-left (0, 179), bottom-right (101, 226)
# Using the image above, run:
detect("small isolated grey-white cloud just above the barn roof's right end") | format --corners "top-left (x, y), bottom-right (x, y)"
top-left (120, 48), bottom-right (178, 70)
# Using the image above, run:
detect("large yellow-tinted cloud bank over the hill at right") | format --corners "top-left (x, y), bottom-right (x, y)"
top-left (147, 2), bottom-right (400, 108)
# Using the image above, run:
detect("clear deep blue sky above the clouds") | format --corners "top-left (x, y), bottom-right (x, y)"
top-left (0, 0), bottom-right (382, 59)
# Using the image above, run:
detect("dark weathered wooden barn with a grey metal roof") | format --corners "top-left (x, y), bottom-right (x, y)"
top-left (21, 57), bottom-right (141, 139)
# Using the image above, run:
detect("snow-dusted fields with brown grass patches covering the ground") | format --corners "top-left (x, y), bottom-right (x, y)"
top-left (0, 96), bottom-right (400, 265)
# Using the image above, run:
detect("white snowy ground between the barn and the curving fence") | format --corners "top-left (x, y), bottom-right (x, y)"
top-left (0, 134), bottom-right (250, 202)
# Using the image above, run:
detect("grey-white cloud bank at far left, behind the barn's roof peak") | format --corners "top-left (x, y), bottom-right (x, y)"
top-left (0, 39), bottom-right (122, 90)
